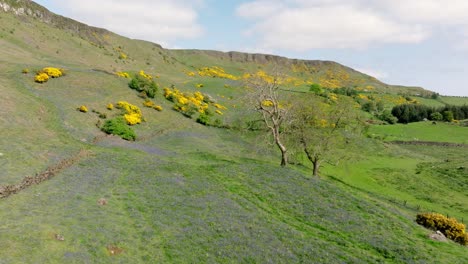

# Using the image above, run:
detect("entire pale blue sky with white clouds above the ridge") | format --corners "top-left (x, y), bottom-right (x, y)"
top-left (35, 0), bottom-right (468, 96)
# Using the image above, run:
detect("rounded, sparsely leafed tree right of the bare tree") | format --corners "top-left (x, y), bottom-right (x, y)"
top-left (288, 97), bottom-right (363, 176)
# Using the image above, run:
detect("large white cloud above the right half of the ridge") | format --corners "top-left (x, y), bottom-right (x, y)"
top-left (236, 0), bottom-right (468, 51)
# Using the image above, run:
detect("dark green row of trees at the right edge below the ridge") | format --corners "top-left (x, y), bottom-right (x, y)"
top-left (392, 104), bottom-right (468, 123)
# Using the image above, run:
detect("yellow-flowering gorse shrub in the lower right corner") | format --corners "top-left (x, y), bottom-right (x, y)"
top-left (416, 213), bottom-right (468, 245)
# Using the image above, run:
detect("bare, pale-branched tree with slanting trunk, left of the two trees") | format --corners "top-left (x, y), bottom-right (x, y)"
top-left (246, 72), bottom-right (288, 167)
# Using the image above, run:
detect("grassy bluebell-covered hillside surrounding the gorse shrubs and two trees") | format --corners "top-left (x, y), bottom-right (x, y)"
top-left (0, 1), bottom-right (468, 263)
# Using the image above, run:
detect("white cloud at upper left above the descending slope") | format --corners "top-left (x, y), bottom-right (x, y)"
top-left (49, 0), bottom-right (203, 46)
